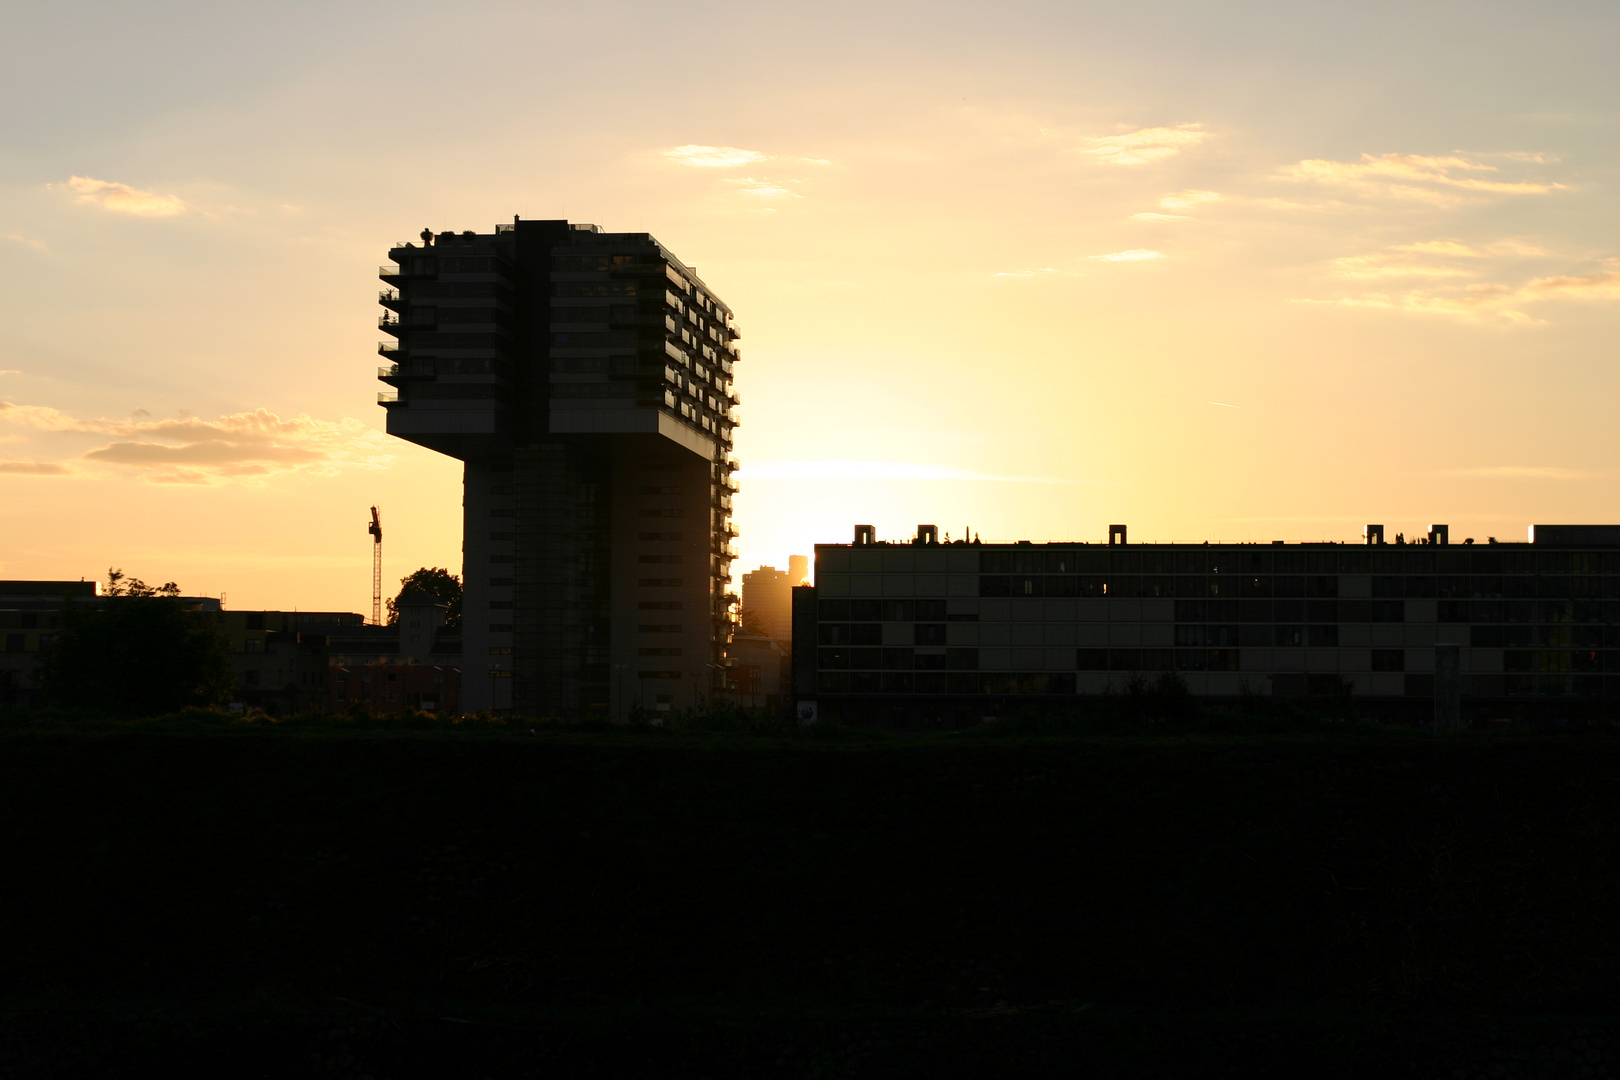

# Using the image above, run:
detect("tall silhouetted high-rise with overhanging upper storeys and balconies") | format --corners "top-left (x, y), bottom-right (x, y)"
top-left (379, 219), bottom-right (737, 717)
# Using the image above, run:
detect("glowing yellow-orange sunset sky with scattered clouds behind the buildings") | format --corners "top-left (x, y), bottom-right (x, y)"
top-left (0, 0), bottom-right (1620, 610)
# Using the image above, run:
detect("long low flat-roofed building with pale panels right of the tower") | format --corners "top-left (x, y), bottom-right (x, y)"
top-left (794, 525), bottom-right (1620, 721)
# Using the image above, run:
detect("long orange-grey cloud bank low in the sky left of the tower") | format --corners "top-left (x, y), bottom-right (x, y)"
top-left (0, 402), bottom-right (394, 484)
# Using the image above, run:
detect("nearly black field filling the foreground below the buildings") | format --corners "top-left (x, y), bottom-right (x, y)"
top-left (0, 729), bottom-right (1620, 1080)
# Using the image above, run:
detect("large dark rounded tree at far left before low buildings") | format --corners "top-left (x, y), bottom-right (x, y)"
top-left (41, 570), bottom-right (237, 716)
